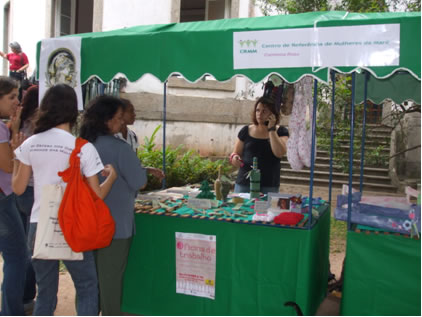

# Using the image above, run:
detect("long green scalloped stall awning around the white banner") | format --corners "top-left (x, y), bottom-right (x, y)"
top-left (38, 11), bottom-right (421, 83)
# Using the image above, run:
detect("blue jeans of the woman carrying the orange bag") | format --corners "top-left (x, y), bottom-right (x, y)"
top-left (29, 223), bottom-right (98, 316)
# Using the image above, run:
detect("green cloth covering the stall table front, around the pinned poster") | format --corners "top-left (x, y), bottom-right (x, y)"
top-left (122, 207), bottom-right (330, 315)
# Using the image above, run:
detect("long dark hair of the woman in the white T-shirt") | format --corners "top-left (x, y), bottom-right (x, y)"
top-left (34, 84), bottom-right (78, 134)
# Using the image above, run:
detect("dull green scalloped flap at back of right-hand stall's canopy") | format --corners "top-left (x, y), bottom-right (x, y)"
top-left (355, 73), bottom-right (421, 105)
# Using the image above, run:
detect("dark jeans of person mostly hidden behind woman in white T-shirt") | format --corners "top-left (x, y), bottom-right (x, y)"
top-left (16, 186), bottom-right (37, 304)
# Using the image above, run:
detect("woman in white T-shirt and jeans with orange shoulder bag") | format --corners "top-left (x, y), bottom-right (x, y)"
top-left (12, 84), bottom-right (117, 315)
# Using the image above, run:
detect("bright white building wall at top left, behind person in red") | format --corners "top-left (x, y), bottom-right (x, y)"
top-left (0, 0), bottom-right (47, 75)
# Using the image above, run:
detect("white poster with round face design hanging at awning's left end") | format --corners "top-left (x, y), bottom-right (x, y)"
top-left (39, 37), bottom-right (83, 110)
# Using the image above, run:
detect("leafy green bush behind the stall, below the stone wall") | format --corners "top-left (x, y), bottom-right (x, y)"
top-left (138, 125), bottom-right (231, 190)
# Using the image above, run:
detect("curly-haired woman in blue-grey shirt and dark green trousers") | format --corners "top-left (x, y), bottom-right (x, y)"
top-left (80, 96), bottom-right (162, 316)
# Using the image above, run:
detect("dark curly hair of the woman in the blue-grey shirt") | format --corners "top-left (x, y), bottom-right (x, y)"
top-left (79, 96), bottom-right (124, 142)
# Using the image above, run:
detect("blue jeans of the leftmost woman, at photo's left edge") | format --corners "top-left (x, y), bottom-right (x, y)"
top-left (0, 193), bottom-right (28, 316)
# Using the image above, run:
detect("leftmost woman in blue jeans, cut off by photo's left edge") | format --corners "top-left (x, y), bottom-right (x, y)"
top-left (0, 76), bottom-right (28, 315)
